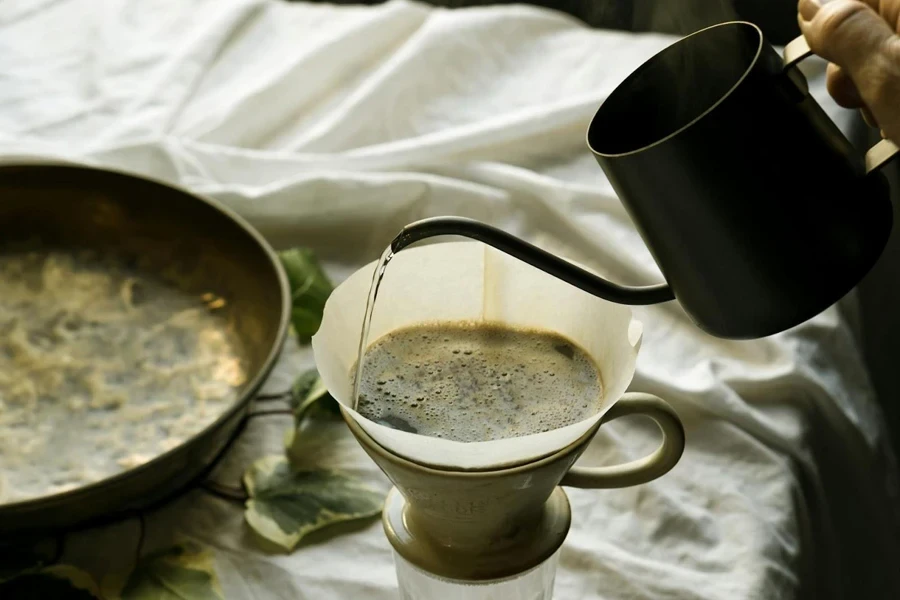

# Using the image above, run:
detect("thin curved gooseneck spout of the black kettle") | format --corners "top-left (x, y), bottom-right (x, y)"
top-left (391, 217), bottom-right (675, 306)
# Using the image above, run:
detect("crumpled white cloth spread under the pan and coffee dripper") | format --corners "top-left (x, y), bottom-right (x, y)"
top-left (0, 0), bottom-right (900, 600)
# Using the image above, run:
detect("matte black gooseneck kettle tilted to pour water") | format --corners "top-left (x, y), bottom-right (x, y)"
top-left (391, 22), bottom-right (897, 339)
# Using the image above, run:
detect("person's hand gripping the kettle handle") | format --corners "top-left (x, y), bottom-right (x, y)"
top-left (797, 0), bottom-right (900, 143)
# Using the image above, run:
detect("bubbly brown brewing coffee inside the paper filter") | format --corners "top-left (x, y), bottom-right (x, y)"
top-left (351, 323), bottom-right (602, 442)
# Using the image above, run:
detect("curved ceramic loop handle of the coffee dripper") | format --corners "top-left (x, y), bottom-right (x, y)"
top-left (560, 392), bottom-right (684, 489)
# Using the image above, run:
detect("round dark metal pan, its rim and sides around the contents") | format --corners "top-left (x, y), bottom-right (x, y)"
top-left (0, 165), bottom-right (290, 540)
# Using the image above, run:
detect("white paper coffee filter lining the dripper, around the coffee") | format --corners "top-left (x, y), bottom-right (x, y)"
top-left (312, 242), bottom-right (642, 470)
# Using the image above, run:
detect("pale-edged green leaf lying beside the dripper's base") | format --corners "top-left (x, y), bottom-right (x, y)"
top-left (244, 456), bottom-right (384, 550)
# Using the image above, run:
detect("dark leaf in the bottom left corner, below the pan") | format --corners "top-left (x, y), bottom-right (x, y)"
top-left (0, 565), bottom-right (100, 600)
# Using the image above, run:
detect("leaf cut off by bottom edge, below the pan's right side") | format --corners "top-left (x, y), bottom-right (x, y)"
top-left (115, 543), bottom-right (224, 600)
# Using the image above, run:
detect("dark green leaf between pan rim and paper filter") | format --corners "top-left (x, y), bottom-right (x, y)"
top-left (278, 248), bottom-right (334, 341)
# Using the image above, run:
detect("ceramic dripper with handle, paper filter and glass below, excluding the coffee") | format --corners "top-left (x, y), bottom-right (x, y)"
top-left (312, 242), bottom-right (684, 600)
